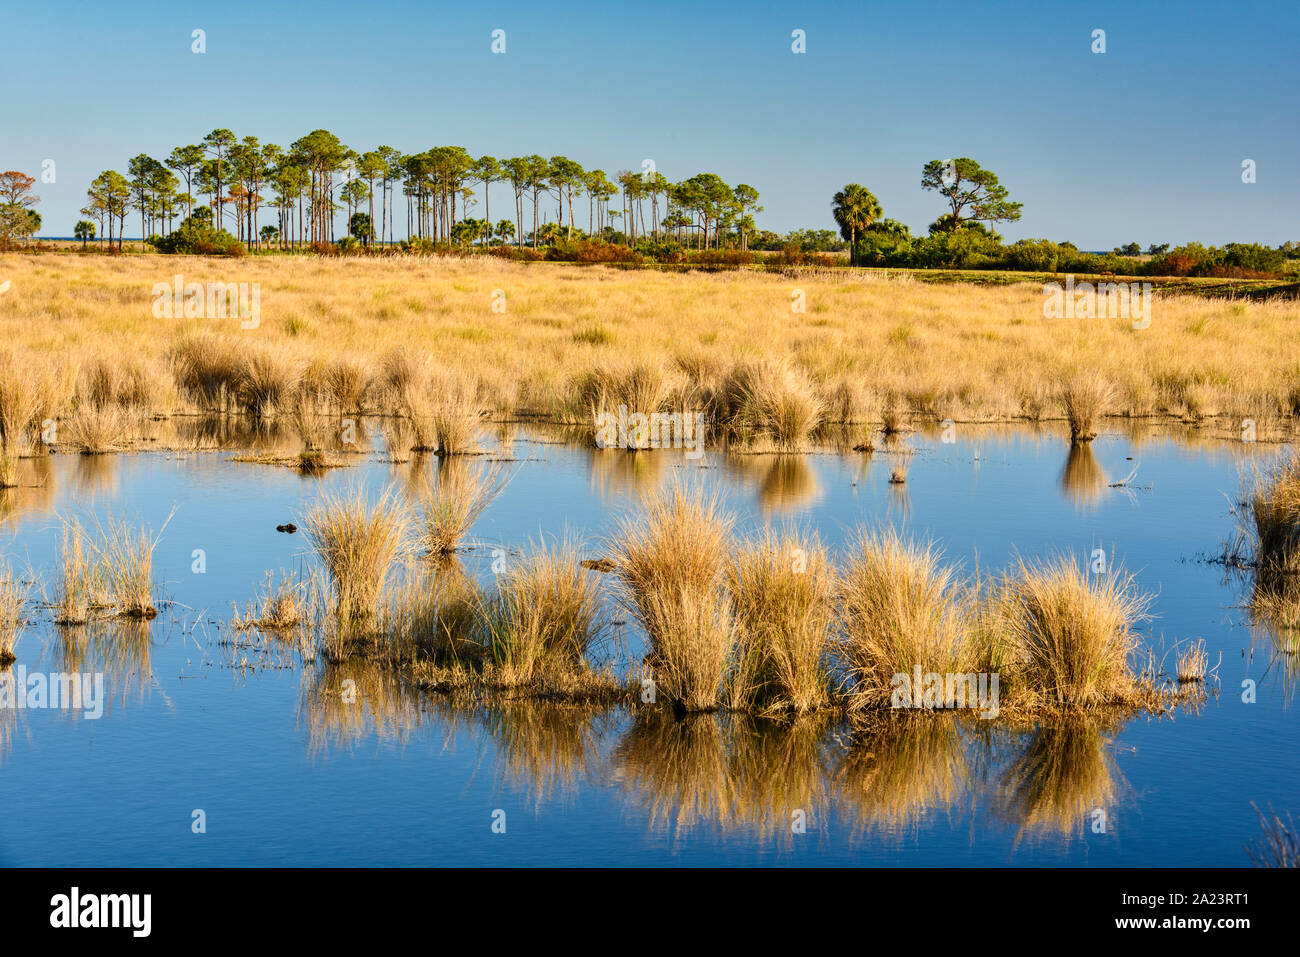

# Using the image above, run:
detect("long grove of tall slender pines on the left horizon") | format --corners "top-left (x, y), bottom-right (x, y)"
top-left (73, 129), bottom-right (762, 250)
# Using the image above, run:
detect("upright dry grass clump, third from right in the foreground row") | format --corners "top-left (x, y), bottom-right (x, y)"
top-left (727, 531), bottom-right (835, 713)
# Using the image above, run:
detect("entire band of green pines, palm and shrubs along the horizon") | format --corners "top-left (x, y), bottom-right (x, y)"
top-left (0, 143), bottom-right (1300, 276)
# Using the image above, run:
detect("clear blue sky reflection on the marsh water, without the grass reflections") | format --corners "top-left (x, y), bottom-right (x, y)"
top-left (0, 433), bottom-right (1300, 865)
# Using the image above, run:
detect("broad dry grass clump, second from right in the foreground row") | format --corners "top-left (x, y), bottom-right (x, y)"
top-left (836, 531), bottom-right (975, 711)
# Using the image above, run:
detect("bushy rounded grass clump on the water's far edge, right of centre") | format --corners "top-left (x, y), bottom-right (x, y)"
top-left (714, 360), bottom-right (827, 451)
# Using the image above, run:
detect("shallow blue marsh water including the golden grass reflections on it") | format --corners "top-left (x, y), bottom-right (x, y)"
top-left (0, 426), bottom-right (1300, 866)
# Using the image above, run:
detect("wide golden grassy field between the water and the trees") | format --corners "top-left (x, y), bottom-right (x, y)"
top-left (0, 254), bottom-right (1300, 438)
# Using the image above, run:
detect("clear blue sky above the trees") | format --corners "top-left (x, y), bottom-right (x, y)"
top-left (0, 0), bottom-right (1300, 248)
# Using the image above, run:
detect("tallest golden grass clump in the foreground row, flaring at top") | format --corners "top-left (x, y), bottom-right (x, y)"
top-left (611, 484), bottom-right (736, 711)
